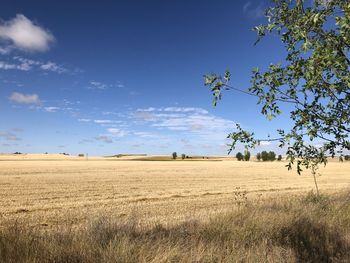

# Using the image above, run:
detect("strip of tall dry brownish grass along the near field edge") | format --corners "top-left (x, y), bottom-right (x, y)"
top-left (0, 193), bottom-right (350, 263)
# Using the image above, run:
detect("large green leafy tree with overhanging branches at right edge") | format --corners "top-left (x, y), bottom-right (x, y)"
top-left (205, 0), bottom-right (350, 194)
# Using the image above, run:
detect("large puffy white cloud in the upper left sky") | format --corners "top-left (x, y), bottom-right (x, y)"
top-left (0, 14), bottom-right (55, 52)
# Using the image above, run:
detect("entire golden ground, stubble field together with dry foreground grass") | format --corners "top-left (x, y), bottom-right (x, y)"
top-left (0, 155), bottom-right (350, 262)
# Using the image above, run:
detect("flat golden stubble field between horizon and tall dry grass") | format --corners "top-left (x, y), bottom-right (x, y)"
top-left (0, 155), bottom-right (350, 227)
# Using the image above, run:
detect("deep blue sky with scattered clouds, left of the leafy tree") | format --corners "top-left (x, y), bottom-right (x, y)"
top-left (0, 0), bottom-right (296, 155)
